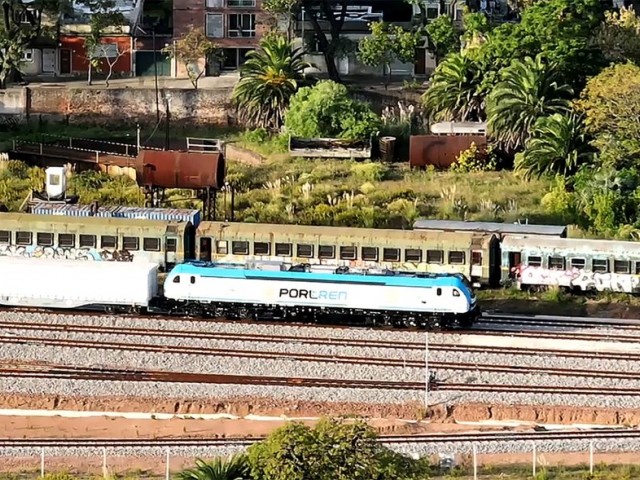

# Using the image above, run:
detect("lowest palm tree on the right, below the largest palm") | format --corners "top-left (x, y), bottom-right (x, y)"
top-left (515, 113), bottom-right (592, 179)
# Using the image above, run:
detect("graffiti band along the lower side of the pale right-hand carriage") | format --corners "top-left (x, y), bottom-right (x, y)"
top-left (514, 265), bottom-right (640, 293)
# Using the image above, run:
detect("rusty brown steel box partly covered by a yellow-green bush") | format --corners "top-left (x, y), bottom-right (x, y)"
top-left (409, 135), bottom-right (487, 168)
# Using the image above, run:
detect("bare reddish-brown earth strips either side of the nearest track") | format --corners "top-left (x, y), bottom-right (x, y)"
top-left (0, 395), bottom-right (640, 477)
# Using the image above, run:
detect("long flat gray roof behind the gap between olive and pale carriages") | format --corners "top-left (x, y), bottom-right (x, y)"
top-left (413, 220), bottom-right (567, 237)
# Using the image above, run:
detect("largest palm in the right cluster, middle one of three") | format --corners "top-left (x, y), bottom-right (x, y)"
top-left (487, 55), bottom-right (573, 151)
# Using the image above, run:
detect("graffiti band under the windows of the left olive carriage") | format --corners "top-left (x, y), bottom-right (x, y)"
top-left (0, 245), bottom-right (133, 262)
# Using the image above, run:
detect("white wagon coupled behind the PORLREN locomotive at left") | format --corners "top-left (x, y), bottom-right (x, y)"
top-left (0, 257), bottom-right (158, 308)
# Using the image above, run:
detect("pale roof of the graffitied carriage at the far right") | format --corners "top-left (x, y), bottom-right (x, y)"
top-left (501, 235), bottom-right (640, 256)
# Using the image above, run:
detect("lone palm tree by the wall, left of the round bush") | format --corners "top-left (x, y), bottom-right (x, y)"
top-left (232, 35), bottom-right (311, 129)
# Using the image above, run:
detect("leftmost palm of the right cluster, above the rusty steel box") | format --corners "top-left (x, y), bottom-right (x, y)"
top-left (422, 53), bottom-right (484, 121)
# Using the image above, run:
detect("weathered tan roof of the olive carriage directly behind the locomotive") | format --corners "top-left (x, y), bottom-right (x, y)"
top-left (198, 222), bottom-right (495, 248)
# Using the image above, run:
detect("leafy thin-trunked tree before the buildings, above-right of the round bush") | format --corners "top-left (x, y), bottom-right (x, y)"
top-left (358, 22), bottom-right (422, 87)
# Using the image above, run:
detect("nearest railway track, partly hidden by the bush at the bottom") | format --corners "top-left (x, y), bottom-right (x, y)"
top-left (0, 429), bottom-right (640, 449)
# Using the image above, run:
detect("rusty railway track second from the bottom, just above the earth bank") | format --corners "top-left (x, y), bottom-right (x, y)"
top-left (5, 364), bottom-right (640, 396)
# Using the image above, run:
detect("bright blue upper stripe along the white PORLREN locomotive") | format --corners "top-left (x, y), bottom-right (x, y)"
top-left (171, 263), bottom-right (473, 304)
